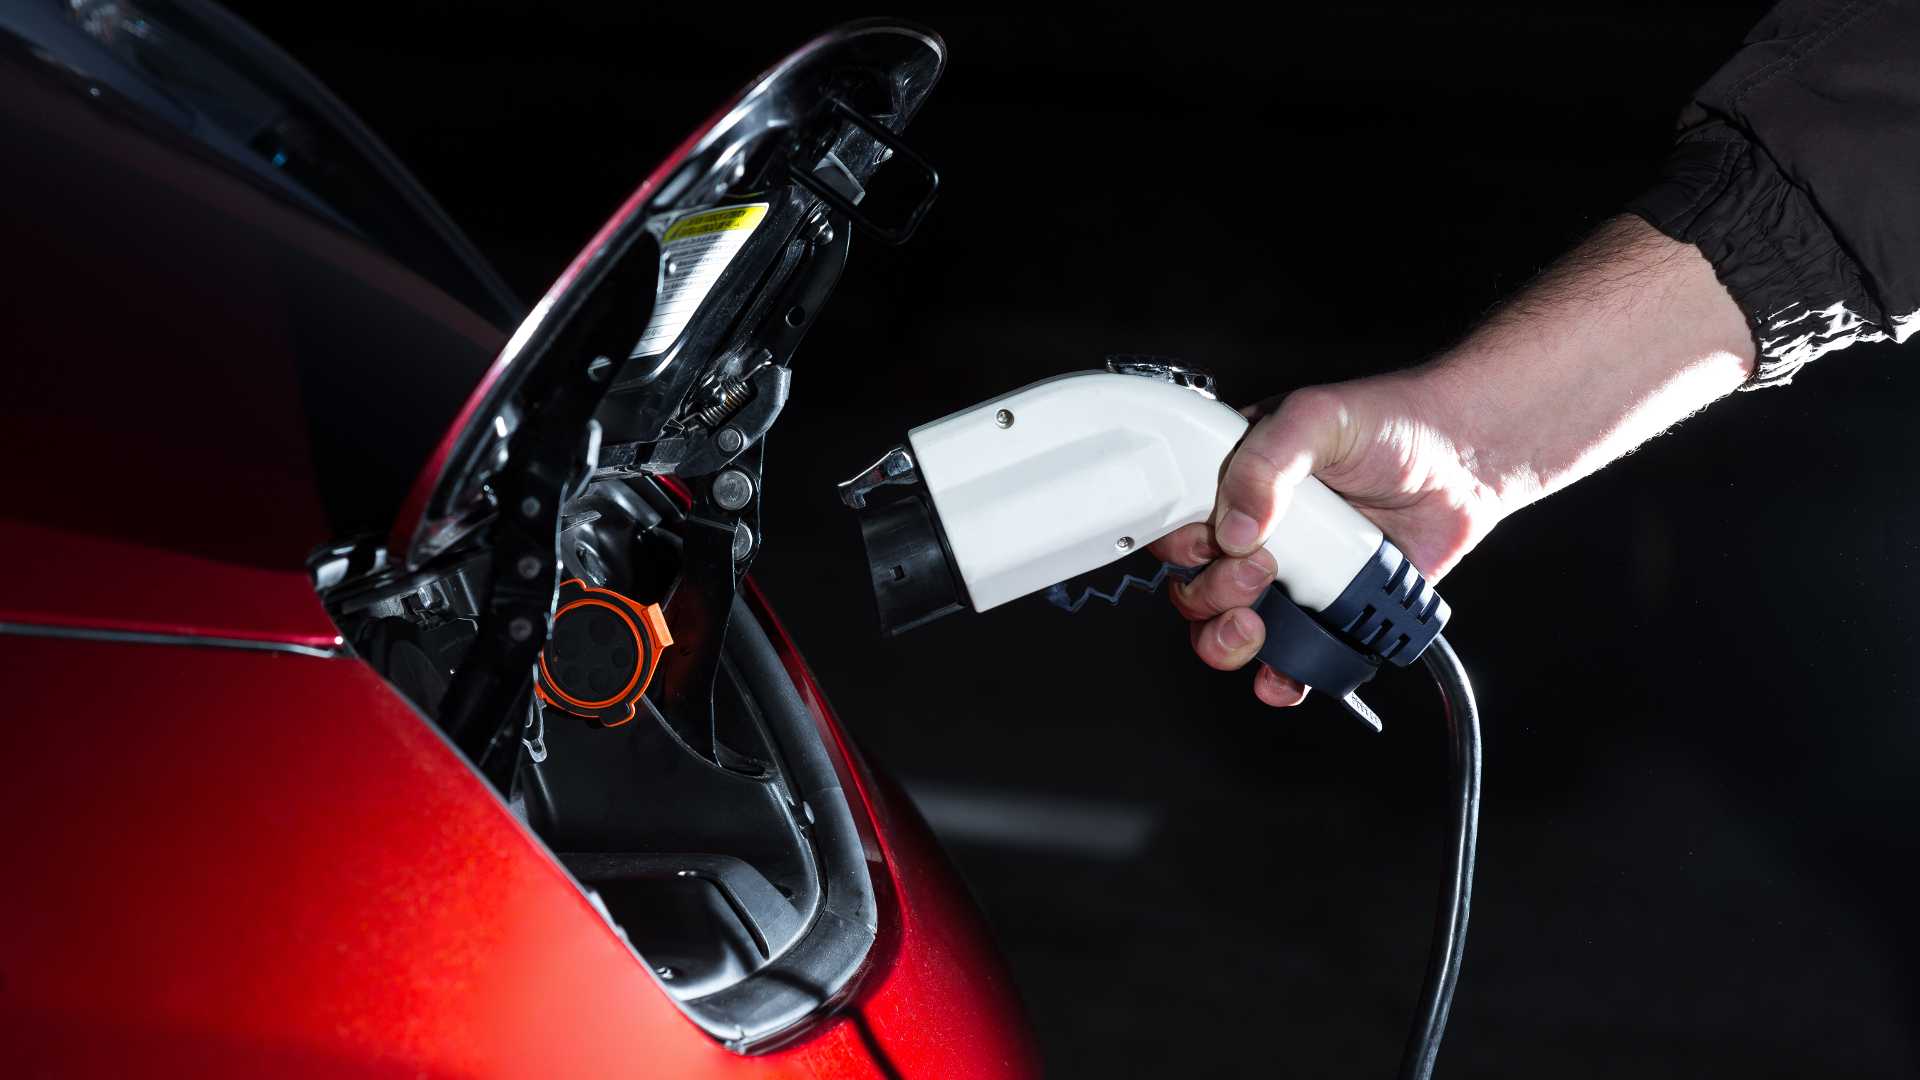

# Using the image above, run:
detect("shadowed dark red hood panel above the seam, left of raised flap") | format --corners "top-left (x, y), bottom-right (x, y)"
top-left (0, 42), bottom-right (505, 646)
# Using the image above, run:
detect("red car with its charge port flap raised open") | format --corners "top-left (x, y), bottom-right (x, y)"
top-left (0, 0), bottom-right (1035, 1078)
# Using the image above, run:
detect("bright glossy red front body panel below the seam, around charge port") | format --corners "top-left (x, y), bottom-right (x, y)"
top-left (0, 636), bottom-right (1035, 1078)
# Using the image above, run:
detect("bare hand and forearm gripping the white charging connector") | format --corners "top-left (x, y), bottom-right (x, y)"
top-left (1152, 217), bottom-right (1755, 705)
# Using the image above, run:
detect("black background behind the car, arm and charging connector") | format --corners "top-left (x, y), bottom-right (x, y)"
top-left (242, 4), bottom-right (1920, 1076)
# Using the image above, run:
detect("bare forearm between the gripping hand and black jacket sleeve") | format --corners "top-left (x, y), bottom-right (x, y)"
top-left (1419, 217), bottom-right (1755, 513)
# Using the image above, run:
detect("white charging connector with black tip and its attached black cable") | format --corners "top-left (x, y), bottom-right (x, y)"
top-left (841, 357), bottom-right (1480, 1080)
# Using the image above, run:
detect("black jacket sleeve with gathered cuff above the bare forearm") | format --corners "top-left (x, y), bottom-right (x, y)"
top-left (1628, 0), bottom-right (1920, 386)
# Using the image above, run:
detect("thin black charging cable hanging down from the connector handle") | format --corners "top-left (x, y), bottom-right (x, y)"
top-left (1400, 636), bottom-right (1480, 1080)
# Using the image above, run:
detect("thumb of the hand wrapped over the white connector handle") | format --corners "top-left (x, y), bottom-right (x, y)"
top-left (1213, 386), bottom-right (1350, 555)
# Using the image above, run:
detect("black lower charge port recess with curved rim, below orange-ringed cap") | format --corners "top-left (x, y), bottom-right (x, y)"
top-left (516, 518), bottom-right (877, 1049)
